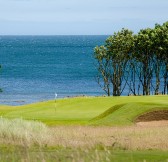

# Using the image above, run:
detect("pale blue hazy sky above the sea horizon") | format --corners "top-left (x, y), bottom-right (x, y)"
top-left (0, 0), bottom-right (168, 35)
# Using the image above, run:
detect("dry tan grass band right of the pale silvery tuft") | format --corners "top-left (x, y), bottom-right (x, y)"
top-left (50, 123), bottom-right (168, 150)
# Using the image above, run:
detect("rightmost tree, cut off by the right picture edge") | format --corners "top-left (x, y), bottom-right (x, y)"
top-left (153, 22), bottom-right (168, 94)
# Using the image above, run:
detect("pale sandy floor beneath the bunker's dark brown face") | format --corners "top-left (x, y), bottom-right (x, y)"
top-left (136, 120), bottom-right (168, 127)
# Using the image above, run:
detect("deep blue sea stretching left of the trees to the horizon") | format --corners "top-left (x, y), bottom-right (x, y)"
top-left (0, 36), bottom-right (108, 105)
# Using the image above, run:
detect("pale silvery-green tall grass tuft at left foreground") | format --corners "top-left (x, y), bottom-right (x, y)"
top-left (0, 117), bottom-right (50, 146)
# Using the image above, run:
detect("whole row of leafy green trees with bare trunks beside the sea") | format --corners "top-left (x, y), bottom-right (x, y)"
top-left (94, 22), bottom-right (168, 96)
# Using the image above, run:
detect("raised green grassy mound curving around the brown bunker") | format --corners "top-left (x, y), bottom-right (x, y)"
top-left (91, 103), bottom-right (168, 126)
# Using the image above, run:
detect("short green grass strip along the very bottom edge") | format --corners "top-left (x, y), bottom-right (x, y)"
top-left (0, 148), bottom-right (168, 162)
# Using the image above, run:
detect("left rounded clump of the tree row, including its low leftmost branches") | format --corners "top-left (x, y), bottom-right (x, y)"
top-left (94, 29), bottom-right (133, 96)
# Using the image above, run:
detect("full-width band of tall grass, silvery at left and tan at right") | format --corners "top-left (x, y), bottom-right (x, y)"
top-left (0, 118), bottom-right (168, 150)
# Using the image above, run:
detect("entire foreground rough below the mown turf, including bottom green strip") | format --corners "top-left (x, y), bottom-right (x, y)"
top-left (0, 119), bottom-right (168, 162)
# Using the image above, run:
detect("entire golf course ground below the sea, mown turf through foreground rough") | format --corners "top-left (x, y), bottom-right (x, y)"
top-left (0, 95), bottom-right (168, 161)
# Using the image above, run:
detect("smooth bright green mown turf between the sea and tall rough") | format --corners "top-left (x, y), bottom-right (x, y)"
top-left (0, 96), bottom-right (168, 125)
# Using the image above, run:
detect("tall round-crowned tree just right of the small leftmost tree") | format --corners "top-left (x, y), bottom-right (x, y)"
top-left (105, 28), bottom-right (134, 96)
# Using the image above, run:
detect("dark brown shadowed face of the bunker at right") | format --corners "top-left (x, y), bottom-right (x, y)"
top-left (135, 110), bottom-right (168, 123)
